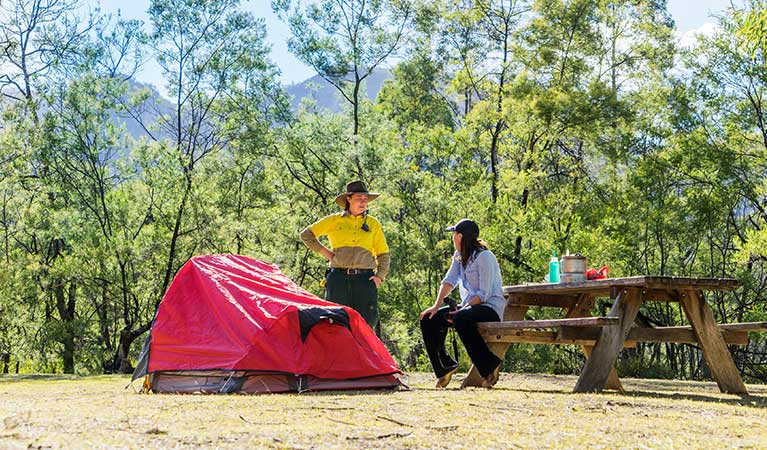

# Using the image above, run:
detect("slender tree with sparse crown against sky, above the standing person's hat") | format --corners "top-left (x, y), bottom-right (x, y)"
top-left (272, 0), bottom-right (414, 173)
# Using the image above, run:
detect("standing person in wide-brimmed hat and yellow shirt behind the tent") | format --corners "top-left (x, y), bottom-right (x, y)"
top-left (300, 181), bottom-right (389, 333)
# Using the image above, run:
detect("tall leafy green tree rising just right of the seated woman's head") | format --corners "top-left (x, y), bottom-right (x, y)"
top-left (443, 1), bottom-right (608, 279)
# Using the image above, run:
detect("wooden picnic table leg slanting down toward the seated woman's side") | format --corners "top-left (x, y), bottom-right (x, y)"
top-left (574, 288), bottom-right (642, 392)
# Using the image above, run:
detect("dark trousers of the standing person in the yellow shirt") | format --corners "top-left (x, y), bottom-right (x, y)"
top-left (325, 270), bottom-right (378, 330)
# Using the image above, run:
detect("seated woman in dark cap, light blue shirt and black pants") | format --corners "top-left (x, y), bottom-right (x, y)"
top-left (420, 219), bottom-right (506, 388)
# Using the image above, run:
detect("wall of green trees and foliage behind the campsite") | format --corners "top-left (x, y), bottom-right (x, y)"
top-left (0, 0), bottom-right (767, 380)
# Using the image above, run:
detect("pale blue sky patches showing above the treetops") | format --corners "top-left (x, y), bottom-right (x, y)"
top-left (88, 0), bottom-right (742, 87)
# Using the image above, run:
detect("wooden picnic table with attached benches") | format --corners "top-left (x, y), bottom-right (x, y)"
top-left (463, 276), bottom-right (767, 394)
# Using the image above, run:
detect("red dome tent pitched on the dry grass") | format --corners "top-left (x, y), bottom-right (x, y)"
top-left (133, 255), bottom-right (403, 393)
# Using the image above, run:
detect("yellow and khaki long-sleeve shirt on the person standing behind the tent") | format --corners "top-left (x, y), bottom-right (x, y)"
top-left (300, 211), bottom-right (390, 280)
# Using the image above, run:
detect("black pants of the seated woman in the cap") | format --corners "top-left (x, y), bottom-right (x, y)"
top-left (421, 305), bottom-right (501, 378)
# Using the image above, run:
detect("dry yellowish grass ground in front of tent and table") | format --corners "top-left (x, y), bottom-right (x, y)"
top-left (0, 373), bottom-right (767, 449)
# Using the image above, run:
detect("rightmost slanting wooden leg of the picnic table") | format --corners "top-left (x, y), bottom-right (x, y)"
top-left (679, 291), bottom-right (748, 394)
